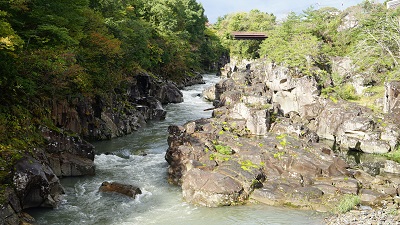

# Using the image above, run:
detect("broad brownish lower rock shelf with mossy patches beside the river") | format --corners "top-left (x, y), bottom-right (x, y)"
top-left (166, 118), bottom-right (397, 211)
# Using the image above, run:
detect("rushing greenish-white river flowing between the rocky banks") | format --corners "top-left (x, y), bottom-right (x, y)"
top-left (29, 75), bottom-right (323, 225)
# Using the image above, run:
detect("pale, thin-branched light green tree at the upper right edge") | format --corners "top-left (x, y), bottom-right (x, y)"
top-left (352, 1), bottom-right (400, 81)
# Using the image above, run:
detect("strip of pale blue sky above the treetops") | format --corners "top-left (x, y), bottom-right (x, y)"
top-left (197, 0), bottom-right (383, 23)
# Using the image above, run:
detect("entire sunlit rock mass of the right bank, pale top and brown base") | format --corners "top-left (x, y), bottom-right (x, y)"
top-left (165, 60), bottom-right (400, 221)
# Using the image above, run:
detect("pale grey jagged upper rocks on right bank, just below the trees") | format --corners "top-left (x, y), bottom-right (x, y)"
top-left (219, 61), bottom-right (400, 153)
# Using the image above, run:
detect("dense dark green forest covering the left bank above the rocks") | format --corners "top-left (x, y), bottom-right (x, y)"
top-left (0, 0), bottom-right (224, 200)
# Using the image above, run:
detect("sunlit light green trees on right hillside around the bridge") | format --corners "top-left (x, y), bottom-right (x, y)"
top-left (214, 1), bottom-right (400, 110)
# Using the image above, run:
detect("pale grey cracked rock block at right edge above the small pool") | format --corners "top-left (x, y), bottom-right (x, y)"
top-left (313, 100), bottom-right (400, 153)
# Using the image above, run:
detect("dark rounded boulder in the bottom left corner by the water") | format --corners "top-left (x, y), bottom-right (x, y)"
top-left (0, 155), bottom-right (64, 225)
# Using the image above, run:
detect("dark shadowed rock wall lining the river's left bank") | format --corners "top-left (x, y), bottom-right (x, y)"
top-left (0, 73), bottom-right (203, 224)
